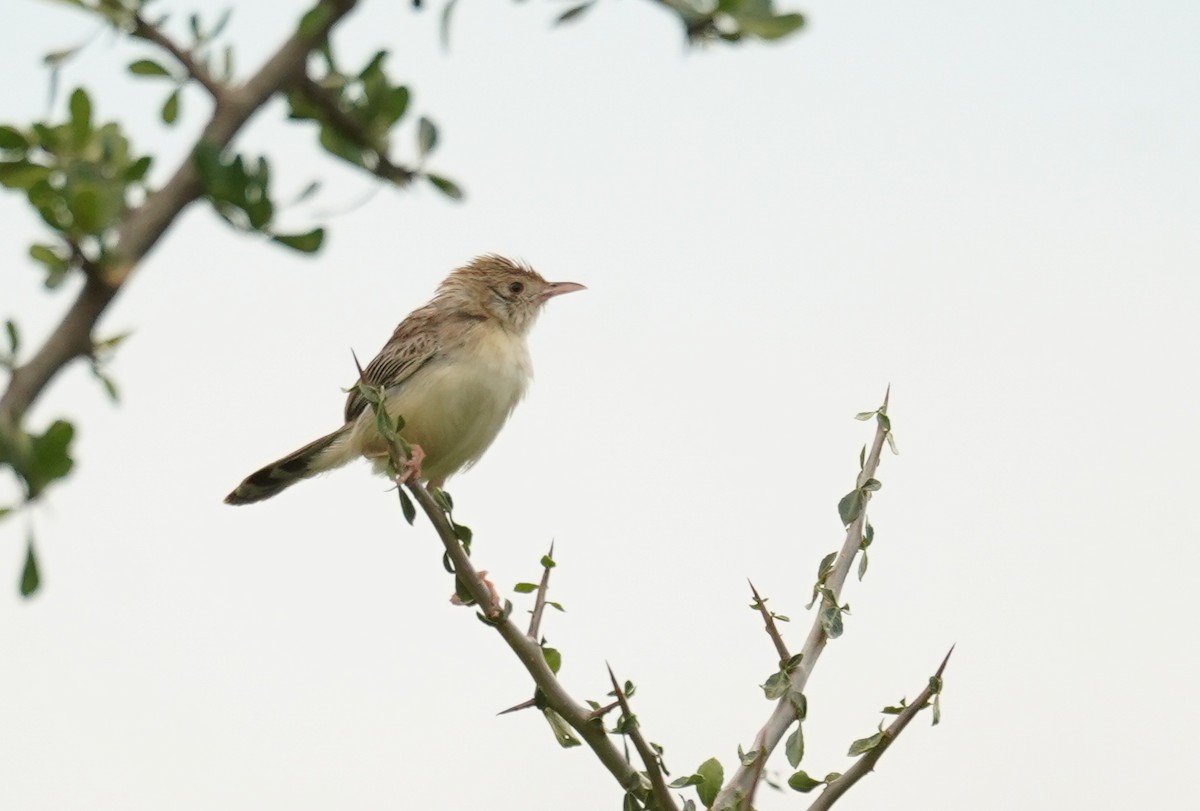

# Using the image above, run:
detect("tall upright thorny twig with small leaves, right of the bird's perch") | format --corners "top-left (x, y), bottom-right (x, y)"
top-left (713, 386), bottom-right (892, 809)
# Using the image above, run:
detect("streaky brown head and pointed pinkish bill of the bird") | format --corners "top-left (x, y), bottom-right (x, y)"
top-left (437, 254), bottom-right (586, 335)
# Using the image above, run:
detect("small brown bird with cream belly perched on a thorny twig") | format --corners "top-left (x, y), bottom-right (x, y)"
top-left (224, 254), bottom-right (587, 504)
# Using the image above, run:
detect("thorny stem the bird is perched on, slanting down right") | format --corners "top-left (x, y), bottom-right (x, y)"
top-left (404, 481), bottom-right (638, 787)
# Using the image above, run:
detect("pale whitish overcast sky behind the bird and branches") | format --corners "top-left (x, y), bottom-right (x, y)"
top-left (0, 0), bottom-right (1200, 811)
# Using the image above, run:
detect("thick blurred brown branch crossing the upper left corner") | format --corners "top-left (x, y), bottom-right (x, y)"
top-left (0, 0), bottom-right (358, 427)
